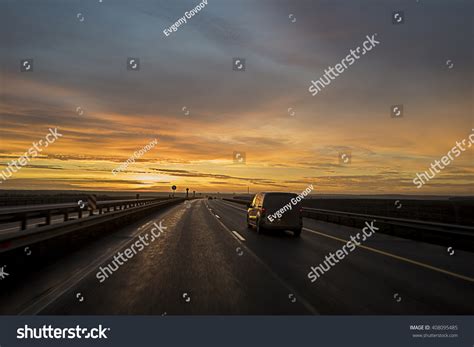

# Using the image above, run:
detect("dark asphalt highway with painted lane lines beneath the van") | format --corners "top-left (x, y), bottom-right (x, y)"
top-left (0, 199), bottom-right (474, 315)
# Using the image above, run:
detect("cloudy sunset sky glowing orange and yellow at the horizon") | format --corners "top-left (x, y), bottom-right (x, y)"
top-left (0, 0), bottom-right (474, 195)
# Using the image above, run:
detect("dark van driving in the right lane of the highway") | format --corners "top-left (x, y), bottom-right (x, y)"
top-left (247, 192), bottom-right (303, 237)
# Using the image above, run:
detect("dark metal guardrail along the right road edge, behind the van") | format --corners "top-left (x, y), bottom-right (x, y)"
top-left (223, 199), bottom-right (474, 237)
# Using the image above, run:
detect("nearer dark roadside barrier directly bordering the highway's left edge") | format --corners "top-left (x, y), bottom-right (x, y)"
top-left (0, 198), bottom-right (184, 274)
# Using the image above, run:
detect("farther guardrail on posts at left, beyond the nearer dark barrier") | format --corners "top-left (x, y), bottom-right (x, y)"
top-left (0, 199), bottom-right (165, 230)
